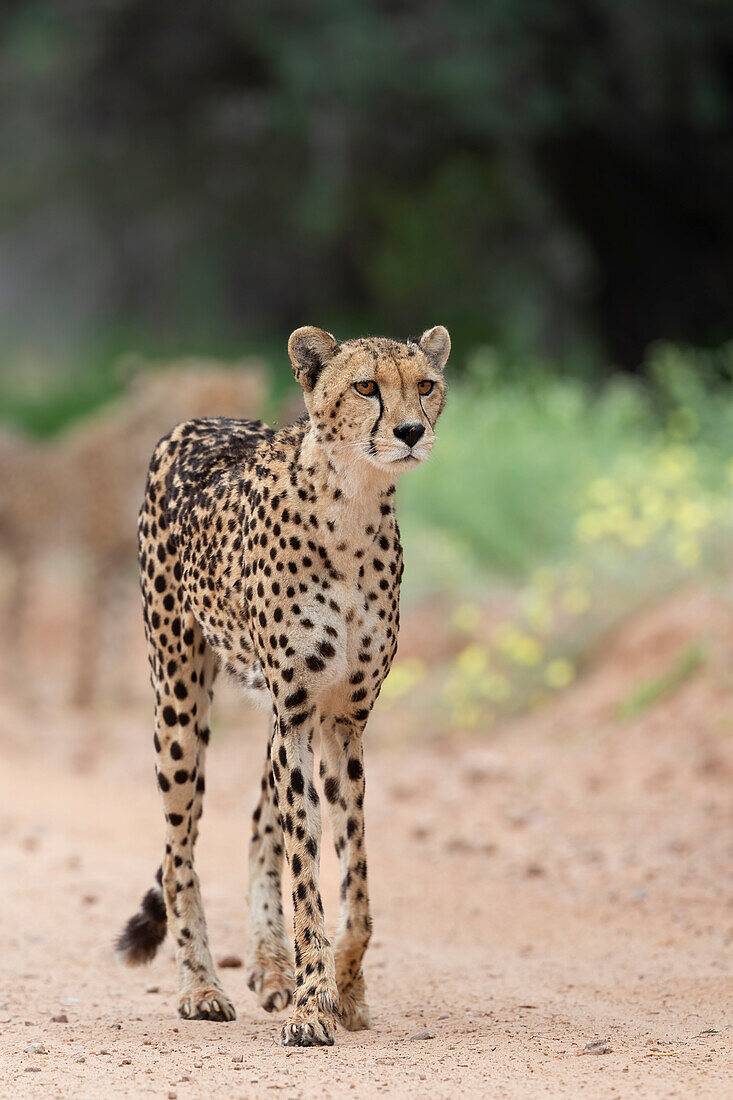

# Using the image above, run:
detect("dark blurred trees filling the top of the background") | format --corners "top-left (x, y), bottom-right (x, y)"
top-left (0, 0), bottom-right (733, 373)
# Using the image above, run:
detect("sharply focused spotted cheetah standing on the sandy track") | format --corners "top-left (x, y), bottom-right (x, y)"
top-left (117, 326), bottom-right (450, 1046)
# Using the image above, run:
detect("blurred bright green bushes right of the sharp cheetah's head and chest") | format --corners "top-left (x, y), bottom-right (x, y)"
top-left (398, 347), bottom-right (733, 592)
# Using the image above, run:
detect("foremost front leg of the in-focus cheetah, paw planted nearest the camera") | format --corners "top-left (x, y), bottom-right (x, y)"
top-left (272, 704), bottom-right (338, 1046)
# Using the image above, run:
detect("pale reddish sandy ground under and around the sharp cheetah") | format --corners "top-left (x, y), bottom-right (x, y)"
top-left (0, 594), bottom-right (733, 1100)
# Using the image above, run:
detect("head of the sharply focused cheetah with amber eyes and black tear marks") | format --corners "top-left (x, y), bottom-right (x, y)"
top-left (287, 325), bottom-right (450, 479)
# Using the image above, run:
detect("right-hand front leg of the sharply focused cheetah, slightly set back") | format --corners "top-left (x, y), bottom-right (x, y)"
top-left (320, 718), bottom-right (372, 1031)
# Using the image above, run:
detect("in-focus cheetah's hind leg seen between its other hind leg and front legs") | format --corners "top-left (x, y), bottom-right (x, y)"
top-left (247, 721), bottom-right (295, 1012)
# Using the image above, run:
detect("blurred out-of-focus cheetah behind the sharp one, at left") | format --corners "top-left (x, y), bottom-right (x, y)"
top-left (0, 359), bottom-right (264, 708)
